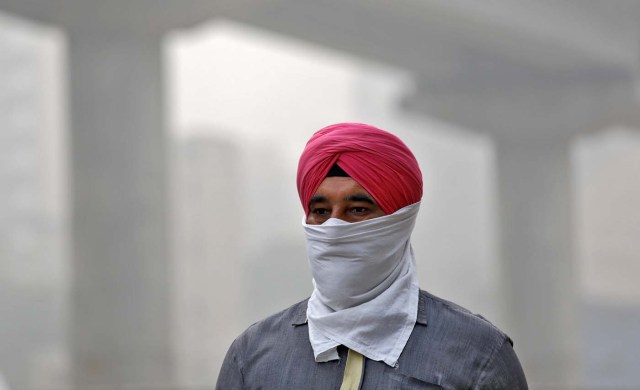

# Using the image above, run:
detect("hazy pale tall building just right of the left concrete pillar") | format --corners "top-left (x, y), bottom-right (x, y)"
top-left (171, 131), bottom-right (246, 388)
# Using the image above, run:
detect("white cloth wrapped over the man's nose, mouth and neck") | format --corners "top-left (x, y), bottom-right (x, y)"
top-left (302, 202), bottom-right (420, 366)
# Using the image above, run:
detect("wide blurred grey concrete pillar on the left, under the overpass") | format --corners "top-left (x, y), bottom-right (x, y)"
top-left (68, 26), bottom-right (171, 389)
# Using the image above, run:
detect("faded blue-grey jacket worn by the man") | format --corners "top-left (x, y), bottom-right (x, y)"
top-left (216, 291), bottom-right (527, 390)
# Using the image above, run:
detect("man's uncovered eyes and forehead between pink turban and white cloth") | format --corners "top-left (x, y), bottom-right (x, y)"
top-left (307, 176), bottom-right (385, 225)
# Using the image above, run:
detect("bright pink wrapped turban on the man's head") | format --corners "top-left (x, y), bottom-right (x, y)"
top-left (297, 123), bottom-right (422, 214)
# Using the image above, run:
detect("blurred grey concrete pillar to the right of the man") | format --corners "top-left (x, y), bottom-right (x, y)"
top-left (496, 136), bottom-right (579, 386)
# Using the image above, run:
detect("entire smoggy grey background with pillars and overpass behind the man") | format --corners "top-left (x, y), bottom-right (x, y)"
top-left (0, 0), bottom-right (640, 390)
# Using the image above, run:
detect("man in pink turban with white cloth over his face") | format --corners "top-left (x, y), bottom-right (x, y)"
top-left (217, 123), bottom-right (527, 390)
